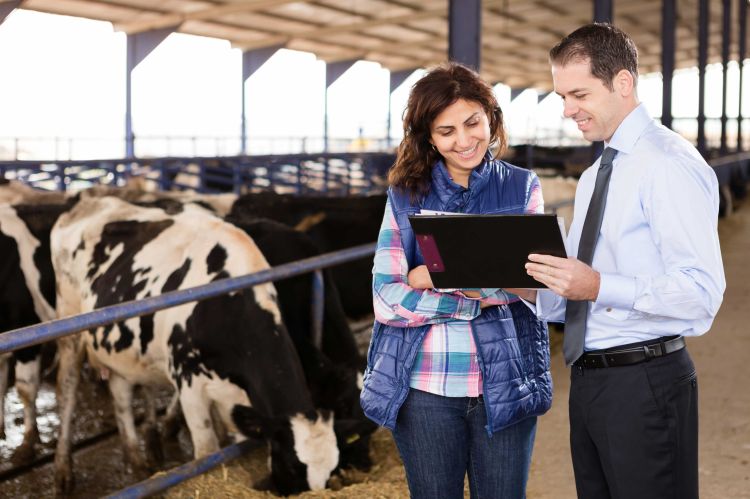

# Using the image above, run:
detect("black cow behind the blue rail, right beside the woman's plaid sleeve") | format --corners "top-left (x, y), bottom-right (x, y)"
top-left (229, 192), bottom-right (386, 318)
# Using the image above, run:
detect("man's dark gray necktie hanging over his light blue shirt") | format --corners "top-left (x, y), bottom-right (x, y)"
top-left (563, 147), bottom-right (617, 365)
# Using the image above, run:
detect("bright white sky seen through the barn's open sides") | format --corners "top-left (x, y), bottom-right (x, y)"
top-left (0, 9), bottom-right (750, 159)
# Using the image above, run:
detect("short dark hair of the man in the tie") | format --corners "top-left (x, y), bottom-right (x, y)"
top-left (549, 23), bottom-right (638, 90)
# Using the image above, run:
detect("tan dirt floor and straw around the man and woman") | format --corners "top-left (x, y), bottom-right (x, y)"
top-left (166, 203), bottom-right (750, 499)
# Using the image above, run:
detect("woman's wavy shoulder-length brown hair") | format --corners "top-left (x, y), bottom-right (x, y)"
top-left (388, 62), bottom-right (507, 199)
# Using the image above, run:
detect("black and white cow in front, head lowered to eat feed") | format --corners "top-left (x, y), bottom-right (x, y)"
top-left (51, 197), bottom-right (339, 493)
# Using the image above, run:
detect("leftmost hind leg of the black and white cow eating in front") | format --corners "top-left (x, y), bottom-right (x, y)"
top-left (55, 335), bottom-right (83, 494)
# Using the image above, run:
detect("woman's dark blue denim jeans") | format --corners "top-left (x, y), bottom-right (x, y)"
top-left (393, 389), bottom-right (536, 499)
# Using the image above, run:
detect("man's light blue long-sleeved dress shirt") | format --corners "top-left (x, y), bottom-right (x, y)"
top-left (536, 104), bottom-right (726, 350)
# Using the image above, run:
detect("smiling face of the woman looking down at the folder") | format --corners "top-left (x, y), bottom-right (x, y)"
top-left (430, 99), bottom-right (490, 187)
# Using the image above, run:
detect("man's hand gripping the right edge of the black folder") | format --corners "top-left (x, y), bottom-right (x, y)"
top-left (526, 253), bottom-right (600, 301)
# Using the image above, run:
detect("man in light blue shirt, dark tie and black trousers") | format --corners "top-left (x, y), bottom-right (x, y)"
top-left (513, 24), bottom-right (725, 499)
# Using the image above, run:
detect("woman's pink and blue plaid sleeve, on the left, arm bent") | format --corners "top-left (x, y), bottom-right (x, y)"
top-left (372, 202), bottom-right (480, 327)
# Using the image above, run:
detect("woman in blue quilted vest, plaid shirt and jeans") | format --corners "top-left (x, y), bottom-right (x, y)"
top-left (361, 63), bottom-right (552, 499)
